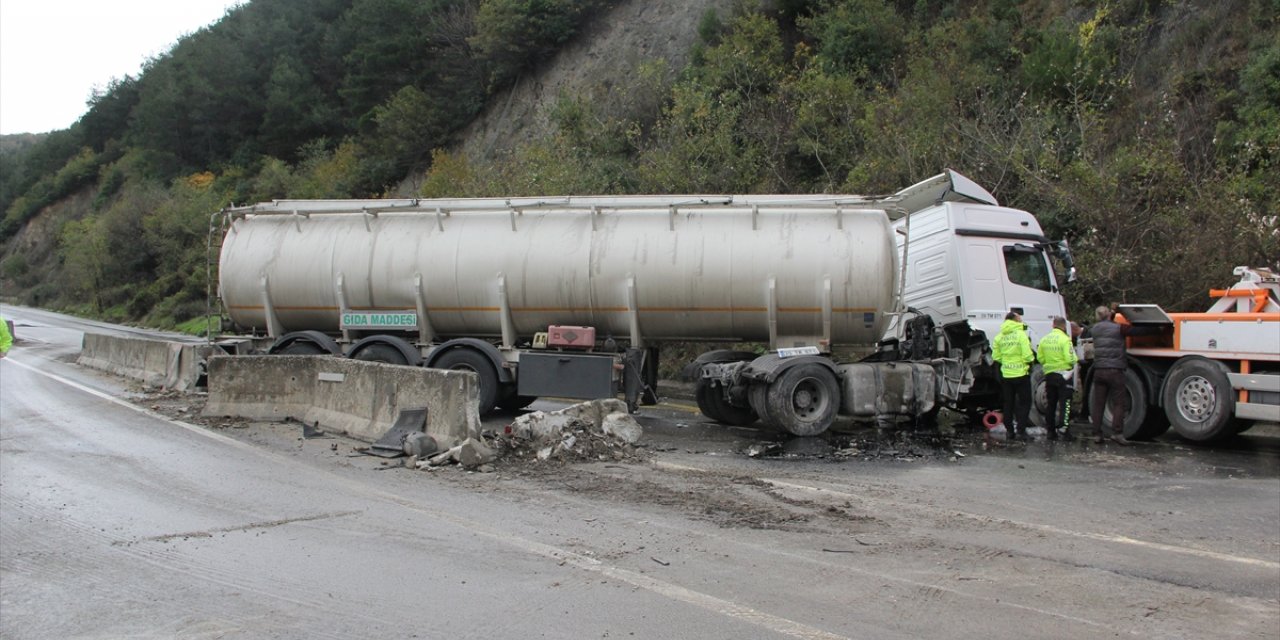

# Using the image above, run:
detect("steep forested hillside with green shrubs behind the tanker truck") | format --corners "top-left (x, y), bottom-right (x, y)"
top-left (0, 0), bottom-right (1280, 326)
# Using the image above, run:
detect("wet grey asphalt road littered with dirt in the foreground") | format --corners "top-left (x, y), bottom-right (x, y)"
top-left (0, 307), bottom-right (1280, 639)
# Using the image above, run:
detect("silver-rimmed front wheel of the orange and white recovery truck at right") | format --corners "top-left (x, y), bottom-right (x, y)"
top-left (1161, 356), bottom-right (1236, 442)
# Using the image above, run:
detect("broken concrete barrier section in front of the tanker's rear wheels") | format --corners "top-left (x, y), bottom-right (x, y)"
top-left (204, 356), bottom-right (480, 448)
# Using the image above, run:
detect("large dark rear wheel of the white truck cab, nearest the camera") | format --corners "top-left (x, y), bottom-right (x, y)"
top-left (765, 362), bottom-right (840, 435)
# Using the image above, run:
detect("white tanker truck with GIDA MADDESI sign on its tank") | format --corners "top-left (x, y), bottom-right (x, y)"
top-left (215, 170), bottom-right (1069, 435)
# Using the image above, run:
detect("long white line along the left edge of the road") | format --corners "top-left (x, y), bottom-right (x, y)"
top-left (5, 358), bottom-right (849, 640)
